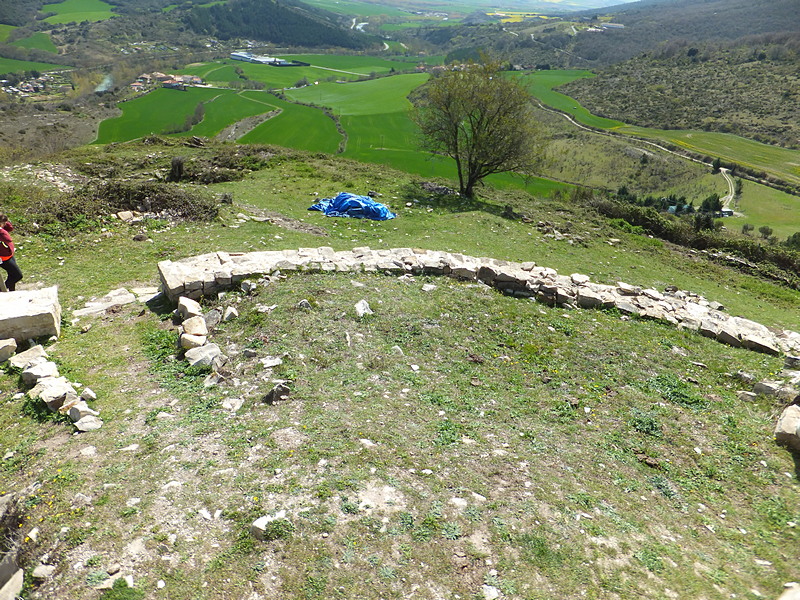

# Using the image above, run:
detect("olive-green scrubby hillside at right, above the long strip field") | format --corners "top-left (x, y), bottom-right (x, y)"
top-left (561, 33), bottom-right (800, 148)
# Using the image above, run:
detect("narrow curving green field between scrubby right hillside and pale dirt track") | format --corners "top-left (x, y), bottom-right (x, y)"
top-left (522, 71), bottom-right (800, 183)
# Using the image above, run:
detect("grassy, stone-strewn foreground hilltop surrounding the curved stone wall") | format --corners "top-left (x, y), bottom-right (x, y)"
top-left (0, 138), bottom-right (800, 600)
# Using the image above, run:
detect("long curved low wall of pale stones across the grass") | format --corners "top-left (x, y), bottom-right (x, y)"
top-left (158, 247), bottom-right (800, 355)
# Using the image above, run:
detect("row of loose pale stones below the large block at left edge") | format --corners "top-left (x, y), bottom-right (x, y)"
top-left (0, 339), bottom-right (103, 431)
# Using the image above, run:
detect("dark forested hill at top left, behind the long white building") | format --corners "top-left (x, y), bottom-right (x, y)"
top-left (185, 0), bottom-right (375, 49)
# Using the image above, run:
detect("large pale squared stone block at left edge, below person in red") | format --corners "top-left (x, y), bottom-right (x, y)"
top-left (0, 286), bottom-right (61, 341)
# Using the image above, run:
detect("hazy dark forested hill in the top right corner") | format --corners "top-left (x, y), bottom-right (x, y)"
top-left (572, 0), bottom-right (800, 65)
